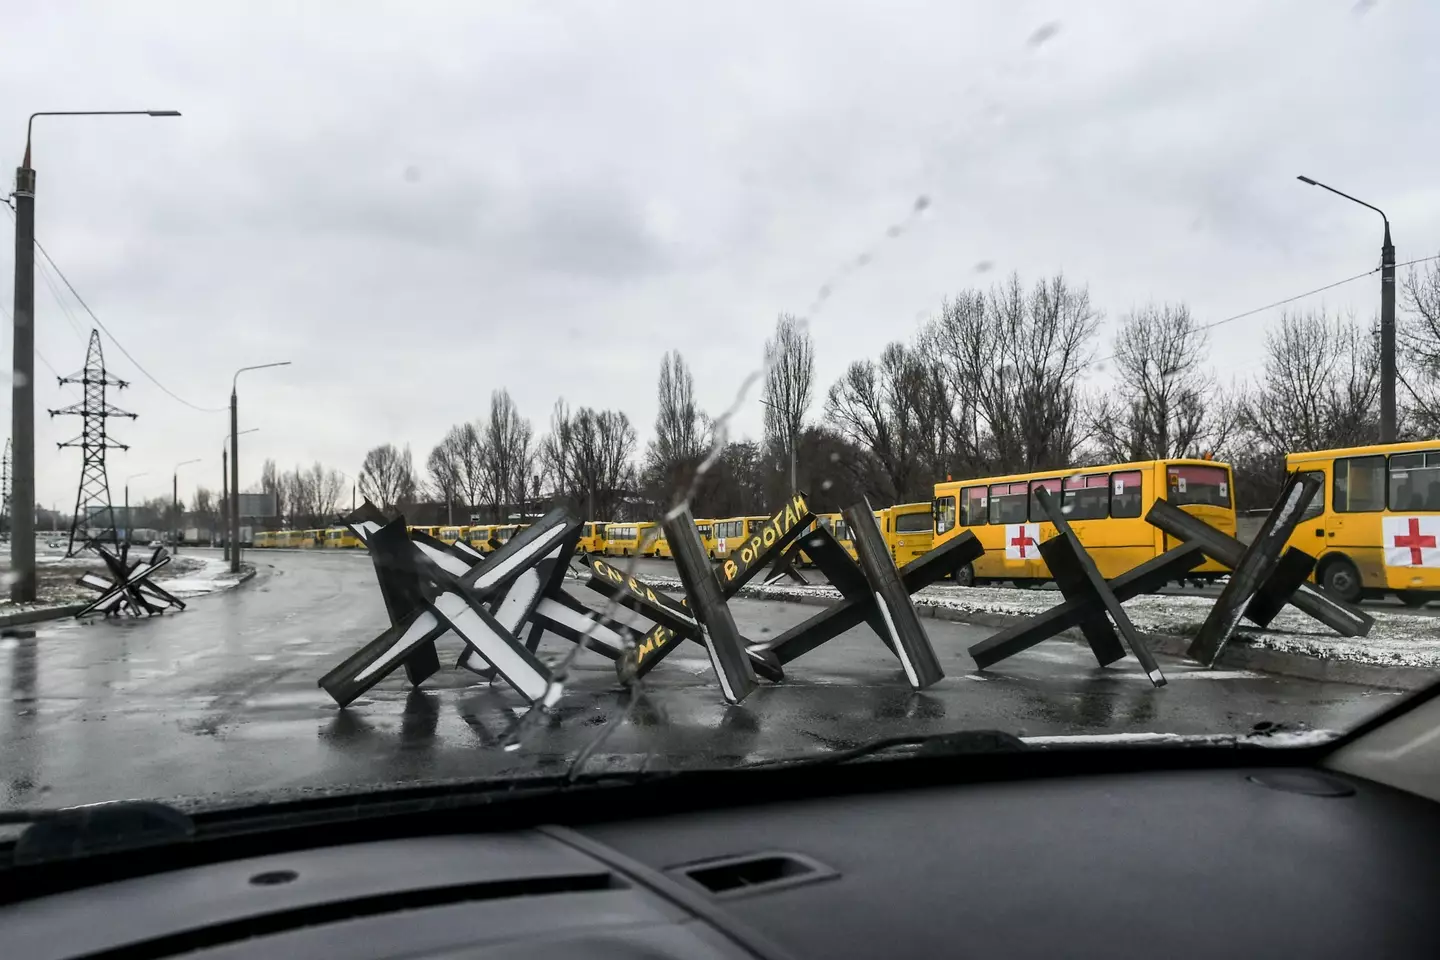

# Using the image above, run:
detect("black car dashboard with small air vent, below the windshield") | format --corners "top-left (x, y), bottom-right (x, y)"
top-left (0, 763), bottom-right (1440, 960)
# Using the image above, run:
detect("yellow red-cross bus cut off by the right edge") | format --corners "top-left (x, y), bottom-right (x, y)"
top-left (1284, 440), bottom-right (1440, 606)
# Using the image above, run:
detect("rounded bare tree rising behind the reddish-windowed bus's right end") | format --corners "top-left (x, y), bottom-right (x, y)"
top-left (1090, 304), bottom-right (1227, 461)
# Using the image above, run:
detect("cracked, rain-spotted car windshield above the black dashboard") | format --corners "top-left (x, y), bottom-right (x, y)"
top-left (0, 0), bottom-right (1440, 810)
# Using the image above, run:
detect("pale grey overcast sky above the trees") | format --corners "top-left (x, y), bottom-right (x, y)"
top-left (0, 0), bottom-right (1440, 510)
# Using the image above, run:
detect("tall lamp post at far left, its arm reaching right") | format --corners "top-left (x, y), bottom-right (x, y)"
top-left (10, 109), bottom-right (180, 603)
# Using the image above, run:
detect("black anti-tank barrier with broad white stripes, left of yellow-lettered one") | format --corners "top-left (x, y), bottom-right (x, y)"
top-left (320, 504), bottom-right (634, 707)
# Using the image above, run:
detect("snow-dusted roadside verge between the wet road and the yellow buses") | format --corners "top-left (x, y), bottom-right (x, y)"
top-left (647, 577), bottom-right (1440, 669)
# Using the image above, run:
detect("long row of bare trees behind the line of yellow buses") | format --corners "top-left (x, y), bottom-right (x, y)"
top-left (289, 262), bottom-right (1440, 524)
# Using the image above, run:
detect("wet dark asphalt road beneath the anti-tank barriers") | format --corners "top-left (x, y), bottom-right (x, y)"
top-left (0, 551), bottom-right (1395, 807)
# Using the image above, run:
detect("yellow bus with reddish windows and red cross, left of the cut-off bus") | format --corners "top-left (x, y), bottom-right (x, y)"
top-left (933, 459), bottom-right (1236, 586)
